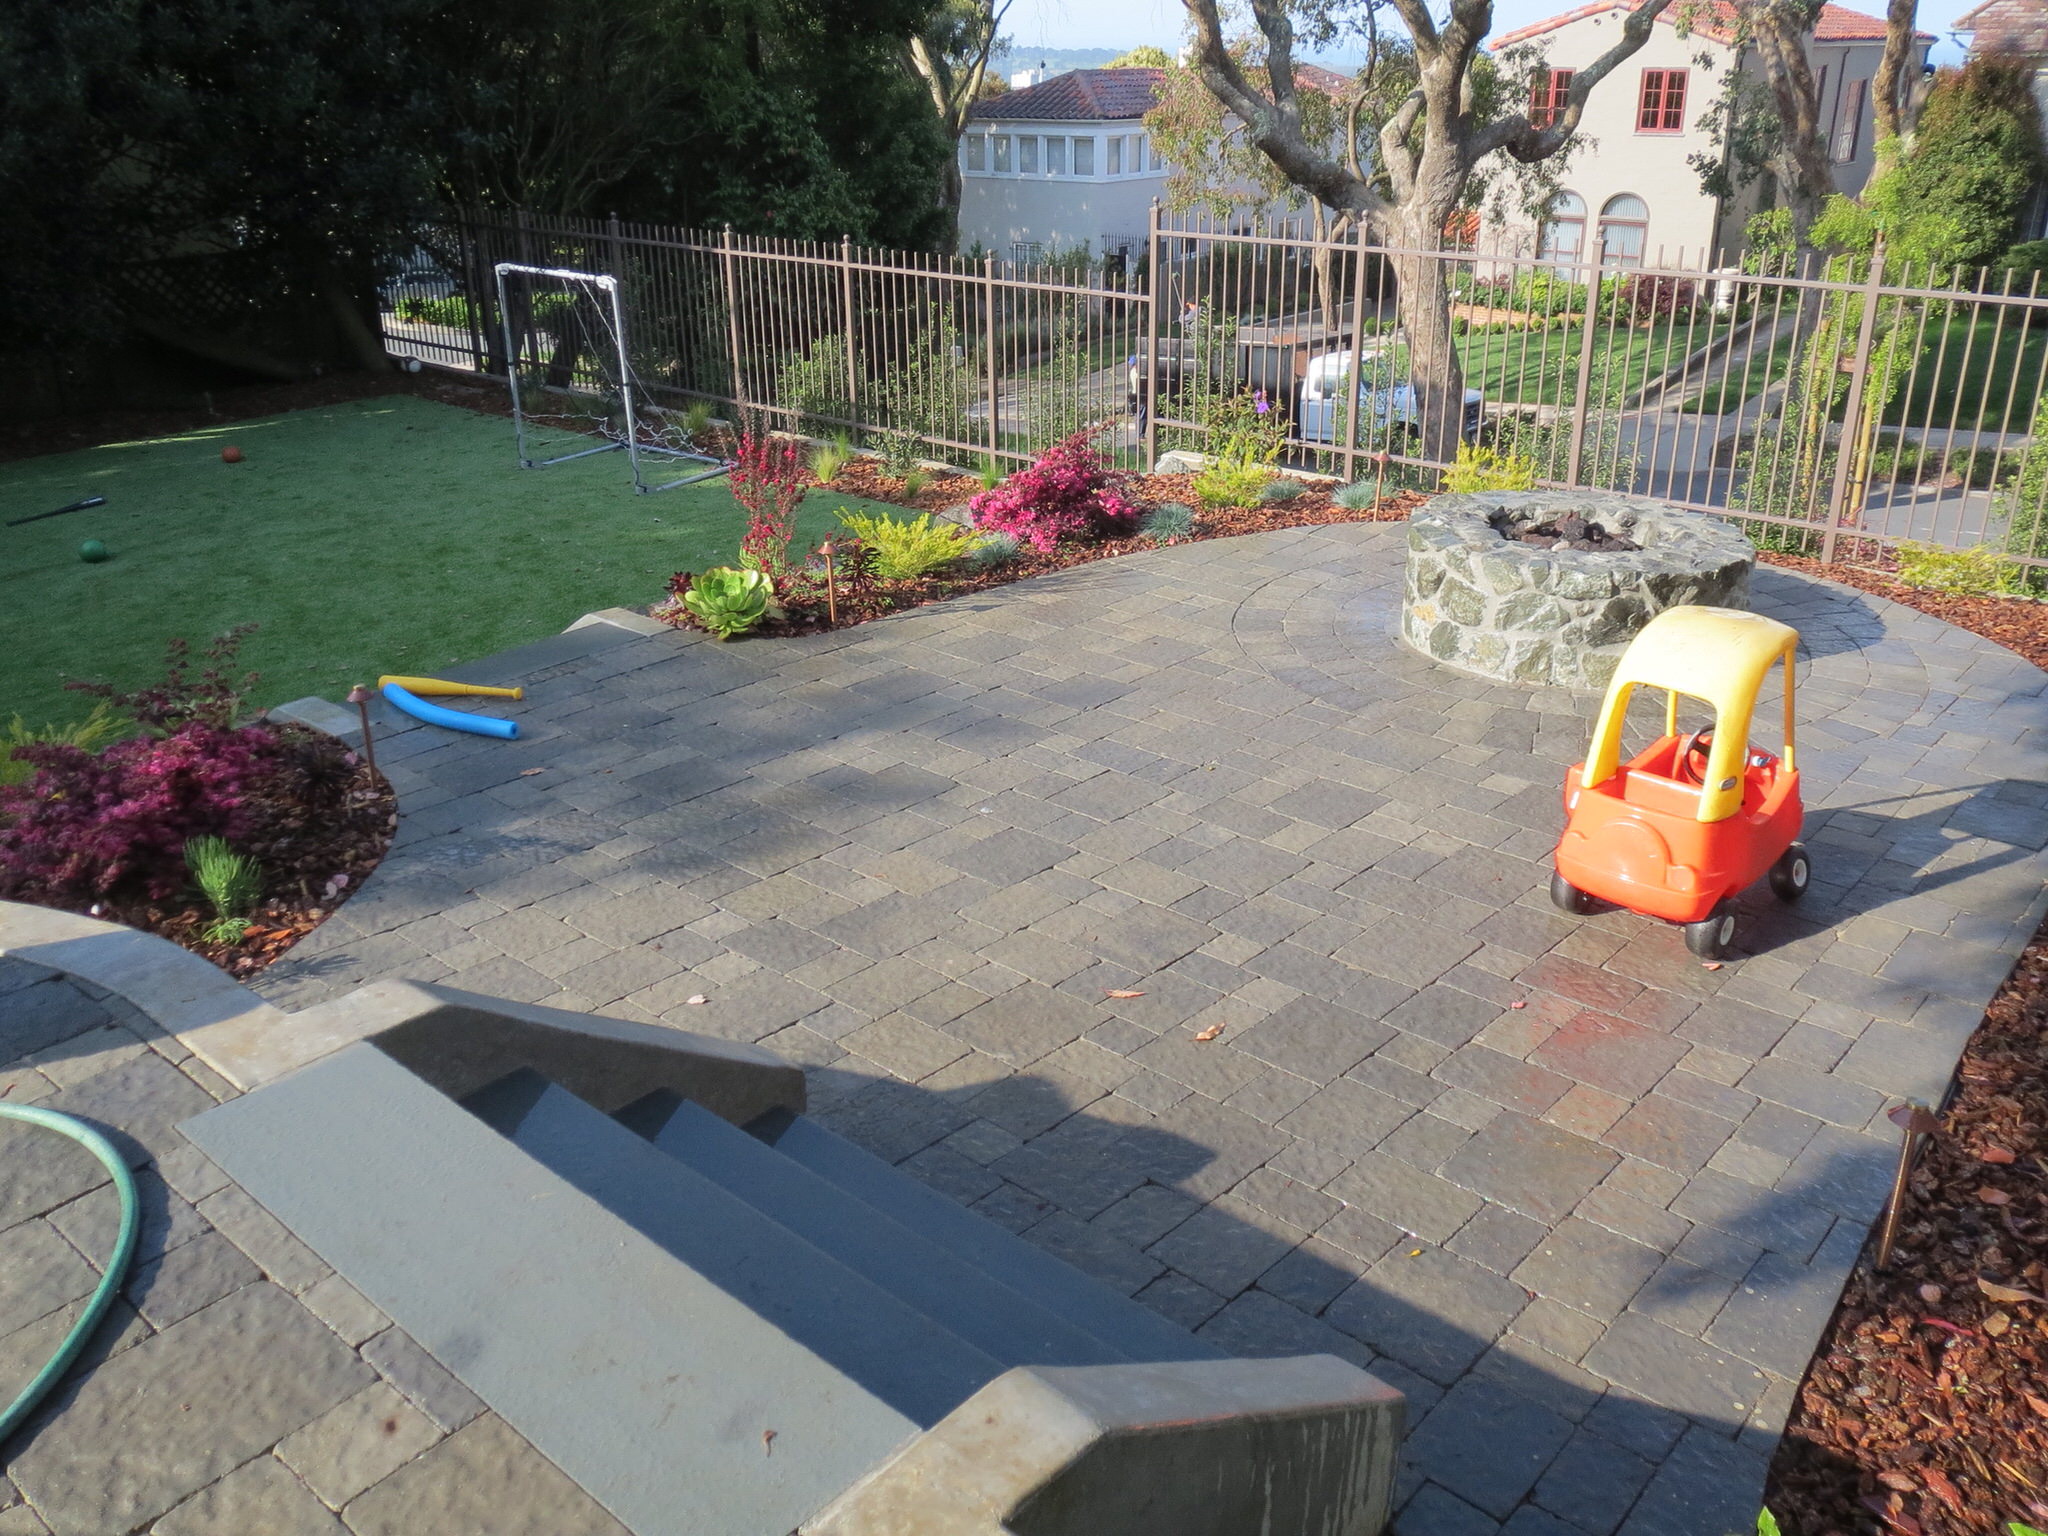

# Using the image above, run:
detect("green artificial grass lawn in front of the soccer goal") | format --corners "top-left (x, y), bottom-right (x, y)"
top-left (0, 395), bottom-right (913, 725)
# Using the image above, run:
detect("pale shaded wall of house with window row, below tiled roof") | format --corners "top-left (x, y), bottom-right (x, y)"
top-left (961, 119), bottom-right (1165, 260)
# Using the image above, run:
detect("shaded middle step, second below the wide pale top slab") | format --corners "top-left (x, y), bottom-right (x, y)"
top-left (614, 1092), bottom-right (1126, 1368)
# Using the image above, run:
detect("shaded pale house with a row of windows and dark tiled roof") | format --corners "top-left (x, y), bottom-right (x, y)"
top-left (961, 70), bottom-right (1165, 262)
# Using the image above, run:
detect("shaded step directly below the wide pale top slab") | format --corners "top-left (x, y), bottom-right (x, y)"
top-left (463, 1069), bottom-right (1010, 1425)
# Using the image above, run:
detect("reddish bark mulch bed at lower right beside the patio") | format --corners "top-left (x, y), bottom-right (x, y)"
top-left (1765, 926), bottom-right (2048, 1536)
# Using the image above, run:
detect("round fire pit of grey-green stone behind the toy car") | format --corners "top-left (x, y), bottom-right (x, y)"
top-left (1401, 492), bottom-right (1757, 688)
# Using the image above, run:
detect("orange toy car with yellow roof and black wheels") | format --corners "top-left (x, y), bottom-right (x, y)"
top-left (1550, 606), bottom-right (1812, 961)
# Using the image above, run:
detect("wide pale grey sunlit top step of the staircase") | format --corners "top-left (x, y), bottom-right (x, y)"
top-left (184, 1042), bottom-right (925, 1536)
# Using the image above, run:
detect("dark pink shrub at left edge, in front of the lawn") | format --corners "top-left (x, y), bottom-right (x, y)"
top-left (0, 721), bottom-right (279, 905)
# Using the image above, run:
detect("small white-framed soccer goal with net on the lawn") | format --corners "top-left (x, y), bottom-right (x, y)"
top-left (498, 262), bottom-right (731, 492)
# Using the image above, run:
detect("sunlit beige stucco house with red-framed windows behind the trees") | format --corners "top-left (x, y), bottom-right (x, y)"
top-left (1481, 0), bottom-right (1933, 268)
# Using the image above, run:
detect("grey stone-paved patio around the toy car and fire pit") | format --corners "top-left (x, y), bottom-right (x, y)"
top-left (262, 524), bottom-right (2048, 1536)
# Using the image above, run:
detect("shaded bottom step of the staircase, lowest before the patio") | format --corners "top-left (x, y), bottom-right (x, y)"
top-left (745, 1110), bottom-right (1225, 1360)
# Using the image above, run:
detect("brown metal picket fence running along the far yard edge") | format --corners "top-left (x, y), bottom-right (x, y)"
top-left (383, 213), bottom-right (2048, 565)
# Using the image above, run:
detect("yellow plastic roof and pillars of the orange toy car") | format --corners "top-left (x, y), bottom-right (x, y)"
top-left (1581, 604), bottom-right (1798, 821)
